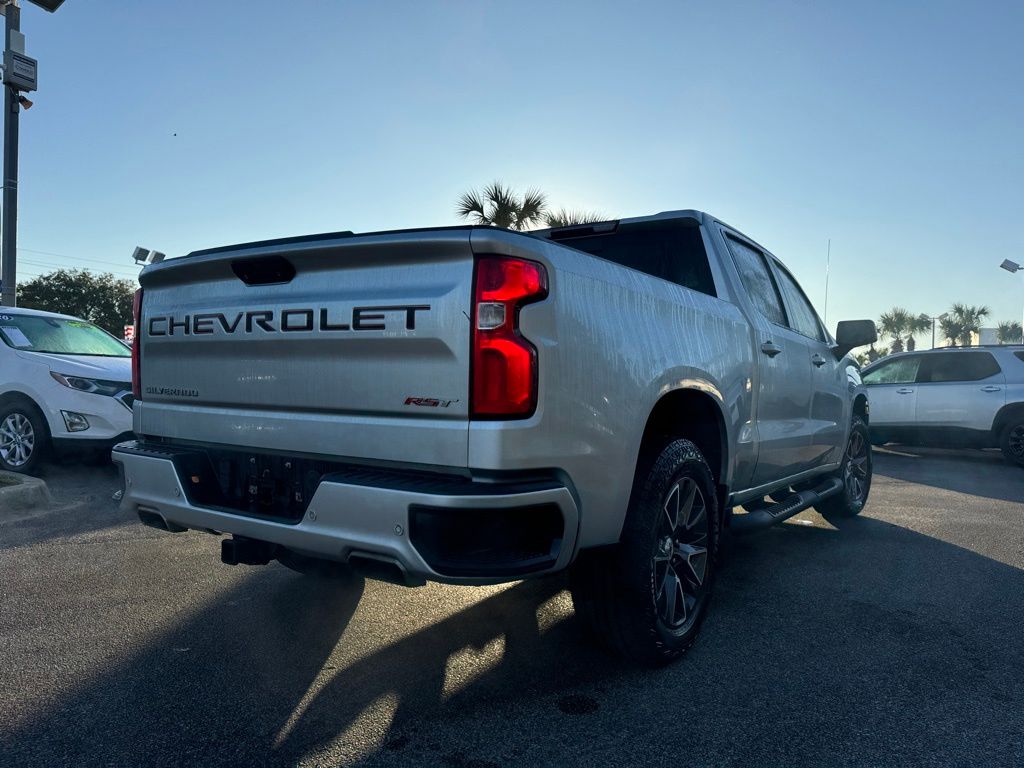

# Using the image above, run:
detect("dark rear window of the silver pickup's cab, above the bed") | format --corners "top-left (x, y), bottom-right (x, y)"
top-left (551, 221), bottom-right (718, 297)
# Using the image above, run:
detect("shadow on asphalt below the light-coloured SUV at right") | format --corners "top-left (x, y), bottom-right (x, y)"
top-left (874, 444), bottom-right (1024, 502)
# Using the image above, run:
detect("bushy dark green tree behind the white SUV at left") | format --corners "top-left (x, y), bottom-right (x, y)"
top-left (17, 269), bottom-right (138, 339)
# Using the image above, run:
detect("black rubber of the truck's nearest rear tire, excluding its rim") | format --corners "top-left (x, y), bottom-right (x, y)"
top-left (569, 439), bottom-right (722, 667)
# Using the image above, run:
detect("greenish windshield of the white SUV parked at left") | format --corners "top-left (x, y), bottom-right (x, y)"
top-left (0, 314), bottom-right (131, 357)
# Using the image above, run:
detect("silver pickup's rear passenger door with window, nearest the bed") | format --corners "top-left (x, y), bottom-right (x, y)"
top-left (726, 232), bottom-right (811, 486)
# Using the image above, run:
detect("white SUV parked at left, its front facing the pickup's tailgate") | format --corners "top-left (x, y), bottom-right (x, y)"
top-left (0, 306), bottom-right (133, 472)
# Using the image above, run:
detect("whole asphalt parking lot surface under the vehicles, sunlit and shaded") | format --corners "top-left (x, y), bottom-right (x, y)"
top-left (0, 449), bottom-right (1024, 768)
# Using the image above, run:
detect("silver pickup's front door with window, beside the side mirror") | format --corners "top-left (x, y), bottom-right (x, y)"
top-left (773, 261), bottom-right (850, 466)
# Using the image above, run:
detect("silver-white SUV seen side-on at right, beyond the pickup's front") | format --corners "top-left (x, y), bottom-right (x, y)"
top-left (861, 344), bottom-right (1024, 466)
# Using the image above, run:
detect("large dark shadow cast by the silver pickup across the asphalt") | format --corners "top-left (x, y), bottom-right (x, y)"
top-left (0, 518), bottom-right (1024, 766)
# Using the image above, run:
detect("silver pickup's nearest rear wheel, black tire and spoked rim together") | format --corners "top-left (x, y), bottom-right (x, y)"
top-left (570, 440), bottom-right (721, 666)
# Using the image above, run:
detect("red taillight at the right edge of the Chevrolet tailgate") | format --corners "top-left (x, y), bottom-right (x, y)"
top-left (470, 256), bottom-right (548, 419)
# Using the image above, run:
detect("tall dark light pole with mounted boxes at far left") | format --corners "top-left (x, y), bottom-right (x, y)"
top-left (0, 0), bottom-right (63, 306)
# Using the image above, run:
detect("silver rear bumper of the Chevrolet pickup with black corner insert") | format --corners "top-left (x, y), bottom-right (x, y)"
top-left (113, 442), bottom-right (580, 584)
